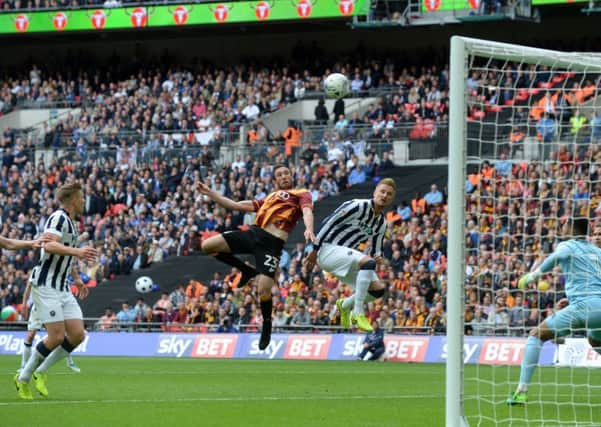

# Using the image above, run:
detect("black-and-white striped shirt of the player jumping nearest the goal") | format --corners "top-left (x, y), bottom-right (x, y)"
top-left (317, 199), bottom-right (386, 256)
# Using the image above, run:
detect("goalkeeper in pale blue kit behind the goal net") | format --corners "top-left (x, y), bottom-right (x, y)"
top-left (507, 218), bottom-right (601, 405)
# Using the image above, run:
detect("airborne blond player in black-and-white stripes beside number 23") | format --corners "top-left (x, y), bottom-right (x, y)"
top-left (306, 178), bottom-right (396, 332)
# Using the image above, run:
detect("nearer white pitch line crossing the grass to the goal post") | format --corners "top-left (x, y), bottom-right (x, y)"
top-left (0, 394), bottom-right (444, 406)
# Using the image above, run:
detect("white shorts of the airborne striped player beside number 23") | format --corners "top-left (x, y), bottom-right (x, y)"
top-left (317, 243), bottom-right (366, 289)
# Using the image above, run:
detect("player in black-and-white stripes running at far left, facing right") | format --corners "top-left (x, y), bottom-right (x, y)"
top-left (15, 183), bottom-right (97, 400)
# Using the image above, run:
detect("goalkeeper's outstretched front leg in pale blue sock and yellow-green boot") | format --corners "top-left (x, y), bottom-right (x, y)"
top-left (507, 304), bottom-right (582, 405)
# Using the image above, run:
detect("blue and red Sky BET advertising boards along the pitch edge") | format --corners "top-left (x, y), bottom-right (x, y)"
top-left (0, 331), bottom-right (601, 367)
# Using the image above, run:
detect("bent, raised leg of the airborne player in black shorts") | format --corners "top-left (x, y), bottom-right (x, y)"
top-left (202, 231), bottom-right (258, 286)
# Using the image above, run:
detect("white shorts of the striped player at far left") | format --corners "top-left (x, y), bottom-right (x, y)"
top-left (31, 286), bottom-right (83, 325)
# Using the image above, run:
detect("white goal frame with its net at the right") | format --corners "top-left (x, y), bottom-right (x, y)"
top-left (445, 36), bottom-right (601, 427)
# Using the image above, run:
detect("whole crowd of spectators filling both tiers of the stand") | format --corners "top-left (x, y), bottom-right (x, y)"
top-left (0, 56), bottom-right (601, 334)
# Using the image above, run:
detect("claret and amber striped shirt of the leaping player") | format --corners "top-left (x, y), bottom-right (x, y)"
top-left (253, 188), bottom-right (313, 233)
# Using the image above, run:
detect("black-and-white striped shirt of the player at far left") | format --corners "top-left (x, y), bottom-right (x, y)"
top-left (31, 209), bottom-right (79, 291)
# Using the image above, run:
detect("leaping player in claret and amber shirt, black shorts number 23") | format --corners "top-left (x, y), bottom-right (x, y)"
top-left (198, 165), bottom-right (315, 350)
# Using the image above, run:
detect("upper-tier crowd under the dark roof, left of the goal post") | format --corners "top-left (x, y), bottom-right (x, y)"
top-left (0, 59), bottom-right (448, 147)
